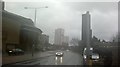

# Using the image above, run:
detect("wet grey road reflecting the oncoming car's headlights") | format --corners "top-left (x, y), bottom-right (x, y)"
top-left (15, 51), bottom-right (83, 65)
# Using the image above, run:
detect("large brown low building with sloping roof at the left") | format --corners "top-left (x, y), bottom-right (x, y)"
top-left (2, 4), bottom-right (42, 53)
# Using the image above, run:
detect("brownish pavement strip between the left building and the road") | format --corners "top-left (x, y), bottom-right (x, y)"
top-left (2, 51), bottom-right (55, 65)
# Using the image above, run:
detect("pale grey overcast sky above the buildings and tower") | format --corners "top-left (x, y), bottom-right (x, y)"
top-left (5, 0), bottom-right (118, 43)
